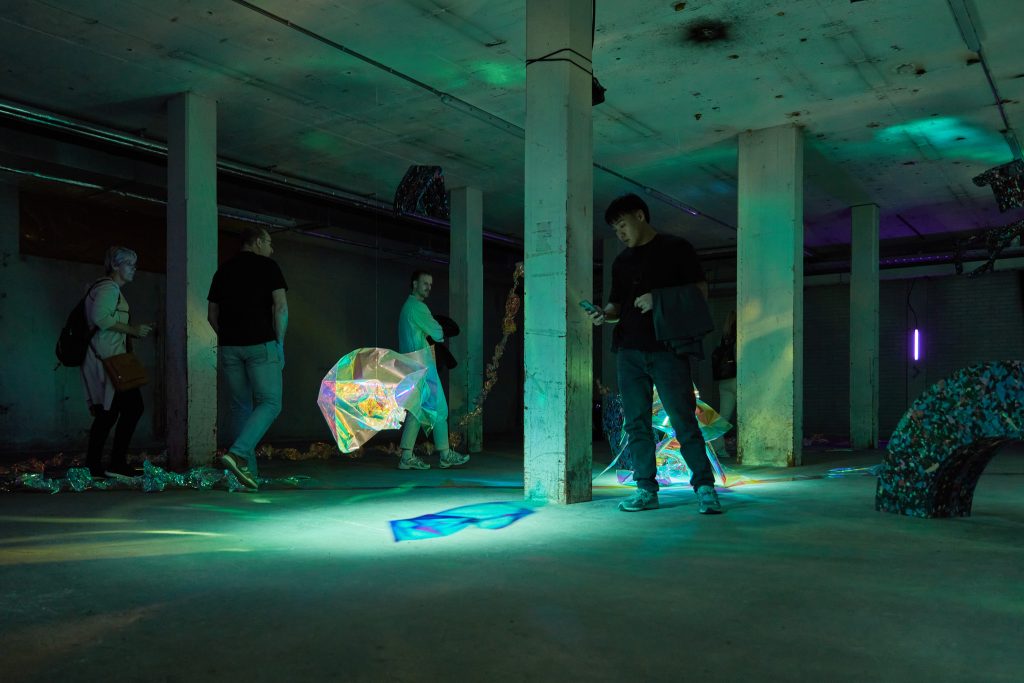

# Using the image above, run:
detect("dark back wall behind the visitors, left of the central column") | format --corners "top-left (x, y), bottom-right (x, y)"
top-left (0, 184), bottom-right (522, 452)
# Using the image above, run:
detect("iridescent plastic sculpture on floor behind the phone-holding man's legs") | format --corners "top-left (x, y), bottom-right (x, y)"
top-left (602, 388), bottom-right (732, 486)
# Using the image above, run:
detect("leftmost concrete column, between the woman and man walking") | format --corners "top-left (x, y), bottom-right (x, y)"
top-left (165, 93), bottom-right (217, 470)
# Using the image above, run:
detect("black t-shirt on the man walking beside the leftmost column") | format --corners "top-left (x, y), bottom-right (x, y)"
top-left (207, 251), bottom-right (288, 346)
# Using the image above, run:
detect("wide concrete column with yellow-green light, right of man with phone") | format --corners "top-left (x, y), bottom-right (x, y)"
top-left (736, 126), bottom-right (804, 467)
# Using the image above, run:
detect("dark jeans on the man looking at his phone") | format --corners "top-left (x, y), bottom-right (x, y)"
top-left (616, 348), bottom-right (715, 492)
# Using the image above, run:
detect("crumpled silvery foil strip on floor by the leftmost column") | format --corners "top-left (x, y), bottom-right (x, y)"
top-left (16, 461), bottom-right (307, 494)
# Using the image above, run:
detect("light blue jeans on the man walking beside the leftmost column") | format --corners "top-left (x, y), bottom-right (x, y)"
top-left (220, 341), bottom-right (284, 475)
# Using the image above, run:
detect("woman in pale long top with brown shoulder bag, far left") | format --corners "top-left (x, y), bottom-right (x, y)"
top-left (82, 247), bottom-right (154, 477)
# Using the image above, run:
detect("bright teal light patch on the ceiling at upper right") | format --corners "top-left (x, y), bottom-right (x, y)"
top-left (876, 117), bottom-right (1012, 164)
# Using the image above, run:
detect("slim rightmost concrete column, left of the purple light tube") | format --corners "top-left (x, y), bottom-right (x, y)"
top-left (850, 204), bottom-right (879, 449)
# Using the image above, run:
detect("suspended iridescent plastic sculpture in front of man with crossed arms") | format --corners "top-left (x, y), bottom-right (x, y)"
top-left (316, 348), bottom-right (447, 453)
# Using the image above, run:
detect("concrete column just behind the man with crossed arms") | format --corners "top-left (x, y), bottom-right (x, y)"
top-left (449, 187), bottom-right (483, 453)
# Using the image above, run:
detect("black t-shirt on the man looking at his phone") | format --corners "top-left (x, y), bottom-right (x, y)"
top-left (608, 232), bottom-right (705, 351)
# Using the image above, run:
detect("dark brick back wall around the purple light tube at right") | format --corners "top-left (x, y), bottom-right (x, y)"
top-left (706, 271), bottom-right (1024, 439)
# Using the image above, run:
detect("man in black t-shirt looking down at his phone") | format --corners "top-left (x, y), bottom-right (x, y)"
top-left (591, 195), bottom-right (722, 514)
